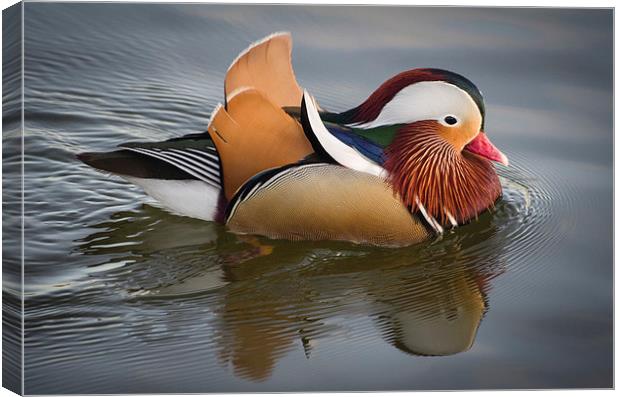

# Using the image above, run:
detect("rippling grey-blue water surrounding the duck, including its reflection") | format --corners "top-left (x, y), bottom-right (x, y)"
top-left (3, 3), bottom-right (613, 393)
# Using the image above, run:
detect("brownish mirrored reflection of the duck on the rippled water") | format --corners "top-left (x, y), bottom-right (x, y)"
top-left (79, 205), bottom-right (506, 381)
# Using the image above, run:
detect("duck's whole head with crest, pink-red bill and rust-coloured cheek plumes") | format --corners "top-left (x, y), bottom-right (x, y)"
top-left (339, 69), bottom-right (508, 224)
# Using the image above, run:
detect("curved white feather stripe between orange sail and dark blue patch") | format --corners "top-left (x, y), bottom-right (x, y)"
top-left (304, 90), bottom-right (386, 177)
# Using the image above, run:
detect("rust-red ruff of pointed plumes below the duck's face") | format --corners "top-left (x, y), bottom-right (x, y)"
top-left (384, 121), bottom-right (501, 225)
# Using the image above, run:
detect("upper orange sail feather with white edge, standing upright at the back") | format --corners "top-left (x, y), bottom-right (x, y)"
top-left (224, 32), bottom-right (302, 108)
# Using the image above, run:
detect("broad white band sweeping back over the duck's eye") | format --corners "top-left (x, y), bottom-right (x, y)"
top-left (346, 81), bottom-right (482, 128)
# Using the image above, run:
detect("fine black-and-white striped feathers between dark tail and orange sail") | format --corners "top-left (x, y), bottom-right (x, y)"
top-left (124, 146), bottom-right (220, 189)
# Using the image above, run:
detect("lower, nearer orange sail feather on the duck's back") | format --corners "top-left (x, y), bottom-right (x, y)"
top-left (208, 88), bottom-right (312, 200)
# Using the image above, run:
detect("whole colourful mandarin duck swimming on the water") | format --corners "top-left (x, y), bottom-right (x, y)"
top-left (78, 33), bottom-right (508, 246)
